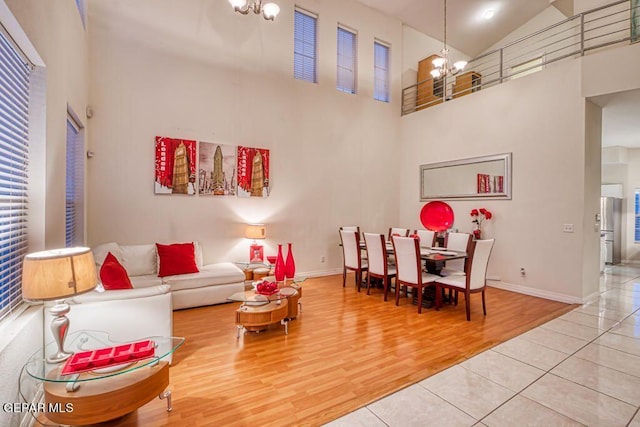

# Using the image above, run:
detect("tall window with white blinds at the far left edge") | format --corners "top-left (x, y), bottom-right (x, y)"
top-left (0, 29), bottom-right (31, 319)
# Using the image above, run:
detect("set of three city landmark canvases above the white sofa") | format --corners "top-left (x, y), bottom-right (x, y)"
top-left (154, 136), bottom-right (269, 197)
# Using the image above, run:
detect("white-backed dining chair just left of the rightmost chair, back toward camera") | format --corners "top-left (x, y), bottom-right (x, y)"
top-left (391, 236), bottom-right (440, 313)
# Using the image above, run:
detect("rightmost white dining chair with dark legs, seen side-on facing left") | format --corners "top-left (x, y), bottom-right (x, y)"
top-left (436, 239), bottom-right (495, 320)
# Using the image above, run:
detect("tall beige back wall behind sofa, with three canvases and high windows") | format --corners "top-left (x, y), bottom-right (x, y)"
top-left (88, 0), bottom-right (402, 272)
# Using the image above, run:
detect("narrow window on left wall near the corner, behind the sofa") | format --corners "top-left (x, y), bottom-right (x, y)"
top-left (65, 114), bottom-right (84, 247)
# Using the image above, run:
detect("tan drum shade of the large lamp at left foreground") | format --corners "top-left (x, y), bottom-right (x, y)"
top-left (22, 247), bottom-right (98, 300)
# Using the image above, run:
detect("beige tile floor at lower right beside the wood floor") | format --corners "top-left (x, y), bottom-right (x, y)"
top-left (326, 266), bottom-right (640, 427)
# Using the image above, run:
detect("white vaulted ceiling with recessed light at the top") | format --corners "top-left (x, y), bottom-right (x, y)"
top-left (359, 0), bottom-right (570, 57)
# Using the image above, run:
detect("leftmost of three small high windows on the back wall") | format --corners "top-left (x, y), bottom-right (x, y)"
top-left (293, 9), bottom-right (318, 83)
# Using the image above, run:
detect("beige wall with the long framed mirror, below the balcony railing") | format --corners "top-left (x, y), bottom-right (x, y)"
top-left (400, 61), bottom-right (599, 302)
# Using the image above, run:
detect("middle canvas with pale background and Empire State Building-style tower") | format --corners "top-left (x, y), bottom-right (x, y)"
top-left (198, 141), bottom-right (237, 196)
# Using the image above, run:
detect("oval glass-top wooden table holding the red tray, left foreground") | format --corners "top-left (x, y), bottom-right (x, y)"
top-left (24, 331), bottom-right (185, 425)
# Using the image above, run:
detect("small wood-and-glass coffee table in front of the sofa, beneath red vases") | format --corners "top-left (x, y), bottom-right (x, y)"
top-left (227, 276), bottom-right (306, 339)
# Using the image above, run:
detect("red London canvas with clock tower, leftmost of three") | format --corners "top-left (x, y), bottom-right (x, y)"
top-left (154, 136), bottom-right (196, 195)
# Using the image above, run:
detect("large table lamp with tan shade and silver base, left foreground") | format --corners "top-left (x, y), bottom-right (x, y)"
top-left (22, 247), bottom-right (98, 363)
